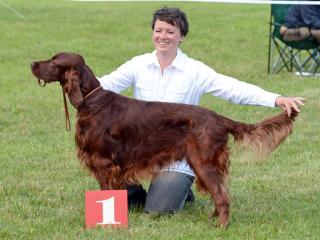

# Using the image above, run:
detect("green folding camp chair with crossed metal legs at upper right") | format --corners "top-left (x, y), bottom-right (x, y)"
top-left (268, 4), bottom-right (320, 76)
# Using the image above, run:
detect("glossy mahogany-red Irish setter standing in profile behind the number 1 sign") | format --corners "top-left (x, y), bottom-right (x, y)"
top-left (31, 53), bottom-right (297, 226)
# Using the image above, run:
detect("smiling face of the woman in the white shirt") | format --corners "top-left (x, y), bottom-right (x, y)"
top-left (152, 20), bottom-right (183, 54)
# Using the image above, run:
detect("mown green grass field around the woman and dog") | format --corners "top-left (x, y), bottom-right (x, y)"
top-left (0, 0), bottom-right (320, 239)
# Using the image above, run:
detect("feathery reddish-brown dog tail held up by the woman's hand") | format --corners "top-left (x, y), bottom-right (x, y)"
top-left (228, 109), bottom-right (298, 156)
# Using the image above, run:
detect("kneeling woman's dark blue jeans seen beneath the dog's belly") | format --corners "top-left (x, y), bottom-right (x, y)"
top-left (128, 171), bottom-right (194, 214)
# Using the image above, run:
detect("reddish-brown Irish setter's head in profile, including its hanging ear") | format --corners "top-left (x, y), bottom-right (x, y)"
top-left (31, 52), bottom-right (86, 108)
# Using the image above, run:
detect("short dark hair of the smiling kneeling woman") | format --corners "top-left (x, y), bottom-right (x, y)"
top-left (151, 7), bottom-right (189, 37)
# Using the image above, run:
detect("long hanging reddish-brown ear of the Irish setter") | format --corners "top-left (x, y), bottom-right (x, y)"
top-left (63, 69), bottom-right (83, 108)
